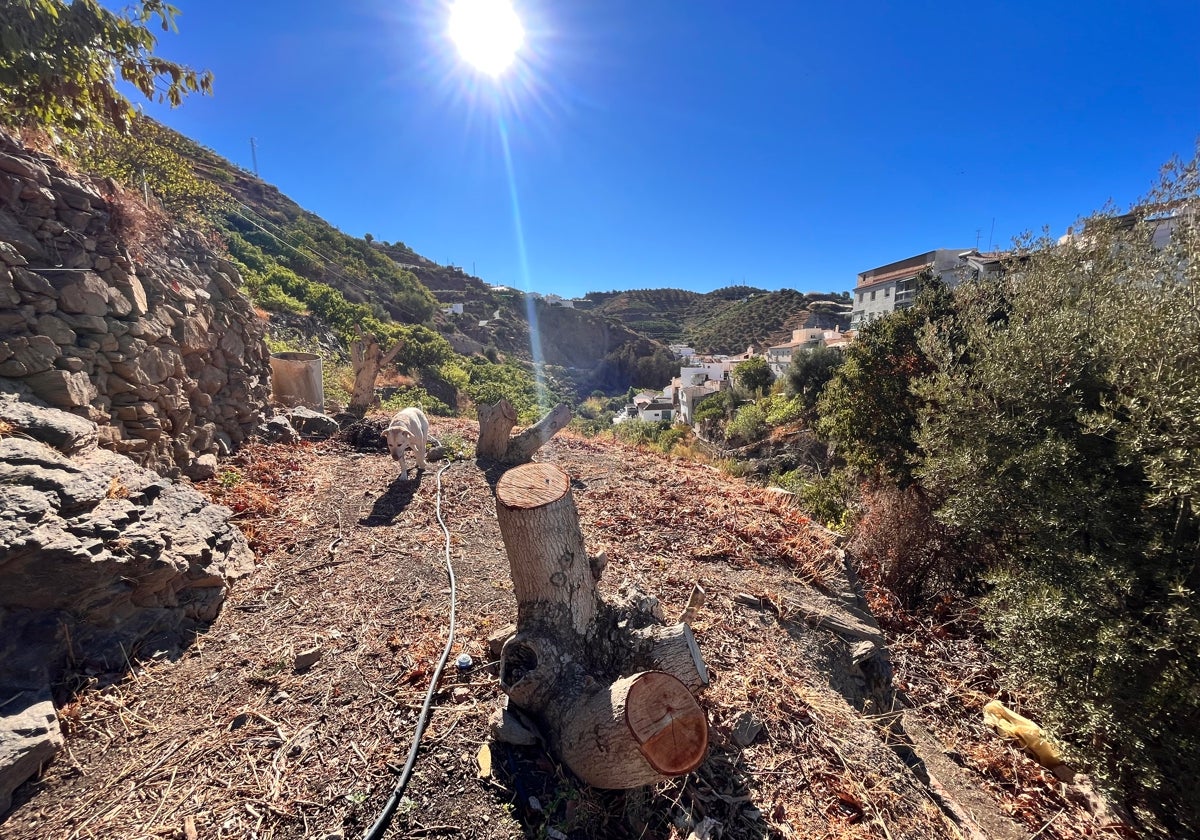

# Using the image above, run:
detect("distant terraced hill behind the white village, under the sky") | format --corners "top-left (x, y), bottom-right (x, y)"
top-left (586, 286), bottom-right (850, 353)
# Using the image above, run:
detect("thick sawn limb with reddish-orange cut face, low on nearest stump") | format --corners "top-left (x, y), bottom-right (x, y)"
top-left (559, 671), bottom-right (708, 787)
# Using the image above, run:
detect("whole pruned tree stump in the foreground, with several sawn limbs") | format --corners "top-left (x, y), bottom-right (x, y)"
top-left (496, 463), bottom-right (708, 788)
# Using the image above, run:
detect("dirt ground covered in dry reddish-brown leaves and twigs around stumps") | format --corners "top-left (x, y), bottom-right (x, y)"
top-left (0, 419), bottom-right (1128, 840)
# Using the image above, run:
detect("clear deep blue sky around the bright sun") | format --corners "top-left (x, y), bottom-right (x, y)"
top-left (131, 0), bottom-right (1200, 296)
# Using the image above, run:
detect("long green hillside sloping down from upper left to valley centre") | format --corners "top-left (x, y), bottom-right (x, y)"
top-left (76, 119), bottom-right (668, 404)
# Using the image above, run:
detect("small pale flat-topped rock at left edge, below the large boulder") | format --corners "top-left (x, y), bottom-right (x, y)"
top-left (0, 685), bottom-right (62, 816)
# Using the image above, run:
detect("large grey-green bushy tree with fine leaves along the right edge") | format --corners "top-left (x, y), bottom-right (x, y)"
top-left (907, 163), bottom-right (1200, 836)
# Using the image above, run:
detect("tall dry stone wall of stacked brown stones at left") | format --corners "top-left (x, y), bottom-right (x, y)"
top-left (0, 132), bottom-right (270, 478)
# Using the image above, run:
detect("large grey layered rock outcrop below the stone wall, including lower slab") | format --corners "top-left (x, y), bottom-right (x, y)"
top-left (0, 396), bottom-right (253, 814)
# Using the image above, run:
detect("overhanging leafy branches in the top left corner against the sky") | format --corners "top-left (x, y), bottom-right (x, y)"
top-left (0, 0), bottom-right (212, 131)
